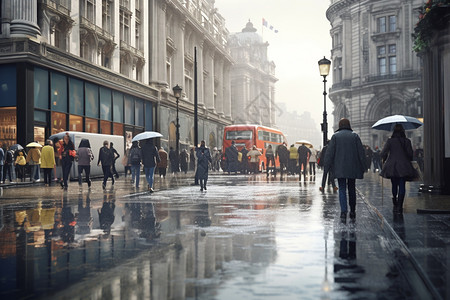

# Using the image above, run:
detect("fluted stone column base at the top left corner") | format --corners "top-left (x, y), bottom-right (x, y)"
top-left (10, 0), bottom-right (41, 37)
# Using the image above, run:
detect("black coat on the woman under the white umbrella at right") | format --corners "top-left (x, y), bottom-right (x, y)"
top-left (380, 137), bottom-right (415, 178)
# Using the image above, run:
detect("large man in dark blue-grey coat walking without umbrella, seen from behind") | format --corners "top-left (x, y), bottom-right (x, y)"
top-left (325, 118), bottom-right (366, 223)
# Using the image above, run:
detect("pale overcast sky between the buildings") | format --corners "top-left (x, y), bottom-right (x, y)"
top-left (215, 0), bottom-right (333, 131)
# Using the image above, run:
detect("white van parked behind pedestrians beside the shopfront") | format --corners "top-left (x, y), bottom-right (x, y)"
top-left (49, 131), bottom-right (125, 179)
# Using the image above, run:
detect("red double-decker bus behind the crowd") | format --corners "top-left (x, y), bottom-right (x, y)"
top-left (222, 125), bottom-right (287, 170)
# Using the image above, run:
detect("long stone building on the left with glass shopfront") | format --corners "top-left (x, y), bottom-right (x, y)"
top-left (0, 0), bottom-right (231, 147)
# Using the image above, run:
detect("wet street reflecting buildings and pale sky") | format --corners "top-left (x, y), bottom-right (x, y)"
top-left (0, 173), bottom-right (431, 299)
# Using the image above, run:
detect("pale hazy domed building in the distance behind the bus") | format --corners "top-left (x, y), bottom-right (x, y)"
top-left (229, 21), bottom-right (278, 127)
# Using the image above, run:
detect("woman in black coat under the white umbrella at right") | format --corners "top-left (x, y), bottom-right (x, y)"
top-left (380, 124), bottom-right (415, 214)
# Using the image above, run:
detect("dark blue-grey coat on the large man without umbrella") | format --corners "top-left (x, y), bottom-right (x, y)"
top-left (325, 129), bottom-right (366, 179)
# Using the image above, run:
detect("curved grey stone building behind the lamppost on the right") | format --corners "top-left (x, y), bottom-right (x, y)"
top-left (326, 0), bottom-right (423, 147)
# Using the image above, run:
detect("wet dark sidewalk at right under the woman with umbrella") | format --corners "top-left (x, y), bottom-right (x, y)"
top-left (357, 173), bottom-right (450, 299)
